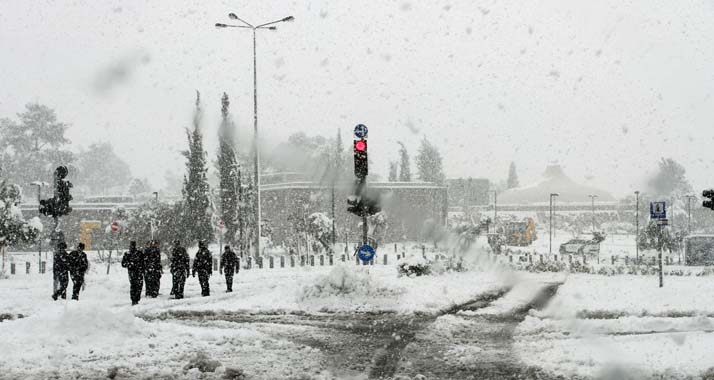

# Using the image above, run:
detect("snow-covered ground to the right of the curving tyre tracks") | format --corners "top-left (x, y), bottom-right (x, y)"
top-left (515, 274), bottom-right (714, 378)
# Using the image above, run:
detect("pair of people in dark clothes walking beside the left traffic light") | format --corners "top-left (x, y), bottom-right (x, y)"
top-left (52, 242), bottom-right (89, 301)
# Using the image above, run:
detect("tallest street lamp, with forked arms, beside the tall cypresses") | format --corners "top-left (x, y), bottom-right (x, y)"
top-left (215, 13), bottom-right (295, 255)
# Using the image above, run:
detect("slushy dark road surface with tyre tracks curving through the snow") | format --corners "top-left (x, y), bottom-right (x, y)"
top-left (151, 283), bottom-right (560, 379)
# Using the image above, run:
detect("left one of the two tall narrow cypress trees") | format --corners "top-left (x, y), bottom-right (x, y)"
top-left (182, 92), bottom-right (213, 245)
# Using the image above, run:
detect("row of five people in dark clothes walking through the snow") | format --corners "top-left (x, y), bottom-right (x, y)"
top-left (121, 240), bottom-right (238, 305)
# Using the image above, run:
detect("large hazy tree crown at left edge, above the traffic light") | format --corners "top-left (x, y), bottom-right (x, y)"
top-left (0, 103), bottom-right (74, 191)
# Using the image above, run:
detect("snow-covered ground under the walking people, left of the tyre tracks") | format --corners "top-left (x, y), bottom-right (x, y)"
top-left (0, 248), bottom-right (516, 379)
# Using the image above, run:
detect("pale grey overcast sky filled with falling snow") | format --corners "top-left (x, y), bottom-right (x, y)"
top-left (0, 0), bottom-right (714, 196)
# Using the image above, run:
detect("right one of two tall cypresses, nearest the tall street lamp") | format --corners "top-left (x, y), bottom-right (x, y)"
top-left (216, 92), bottom-right (241, 243)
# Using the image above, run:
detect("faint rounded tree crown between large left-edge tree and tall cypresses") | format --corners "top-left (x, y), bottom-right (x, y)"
top-left (74, 142), bottom-right (131, 194)
